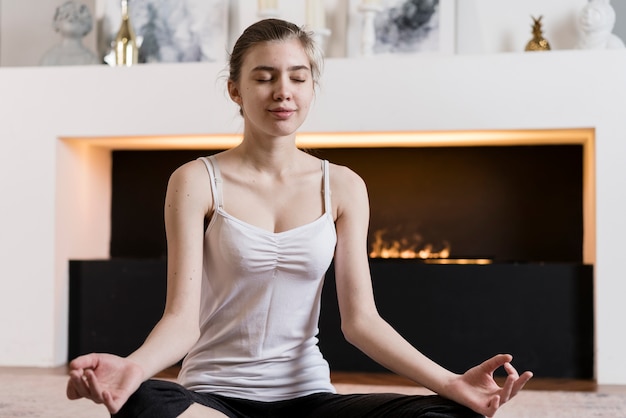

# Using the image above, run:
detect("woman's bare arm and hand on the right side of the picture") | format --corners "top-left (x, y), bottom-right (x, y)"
top-left (331, 165), bottom-right (532, 416)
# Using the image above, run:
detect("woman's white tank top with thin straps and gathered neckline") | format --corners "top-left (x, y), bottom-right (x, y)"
top-left (178, 157), bottom-right (337, 401)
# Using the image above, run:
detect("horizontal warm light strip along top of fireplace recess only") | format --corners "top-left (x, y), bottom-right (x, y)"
top-left (61, 128), bottom-right (594, 150)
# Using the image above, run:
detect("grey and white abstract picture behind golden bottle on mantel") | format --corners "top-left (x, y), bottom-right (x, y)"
top-left (98, 0), bottom-right (230, 64)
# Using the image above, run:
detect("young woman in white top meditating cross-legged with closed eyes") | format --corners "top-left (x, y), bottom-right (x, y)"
top-left (67, 19), bottom-right (532, 418)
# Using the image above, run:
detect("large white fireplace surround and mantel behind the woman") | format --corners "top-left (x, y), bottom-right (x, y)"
top-left (0, 51), bottom-right (626, 384)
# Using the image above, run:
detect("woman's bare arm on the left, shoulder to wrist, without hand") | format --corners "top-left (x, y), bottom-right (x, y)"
top-left (128, 161), bottom-right (212, 378)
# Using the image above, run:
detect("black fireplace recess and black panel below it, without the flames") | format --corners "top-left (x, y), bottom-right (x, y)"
top-left (69, 145), bottom-right (593, 379)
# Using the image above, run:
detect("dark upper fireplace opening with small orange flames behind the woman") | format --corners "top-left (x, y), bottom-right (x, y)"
top-left (111, 144), bottom-right (583, 263)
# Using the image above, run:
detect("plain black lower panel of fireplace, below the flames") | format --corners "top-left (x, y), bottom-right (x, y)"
top-left (68, 258), bottom-right (594, 379)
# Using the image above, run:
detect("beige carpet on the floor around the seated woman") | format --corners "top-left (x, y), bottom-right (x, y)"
top-left (0, 374), bottom-right (626, 418)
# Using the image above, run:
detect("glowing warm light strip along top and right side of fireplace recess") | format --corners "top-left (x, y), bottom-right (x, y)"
top-left (60, 128), bottom-right (596, 264)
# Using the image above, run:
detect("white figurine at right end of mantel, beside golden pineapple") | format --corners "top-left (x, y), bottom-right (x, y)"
top-left (577, 0), bottom-right (624, 49)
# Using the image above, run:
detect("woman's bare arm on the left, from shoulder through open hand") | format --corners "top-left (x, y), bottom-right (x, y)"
top-left (67, 161), bottom-right (213, 413)
